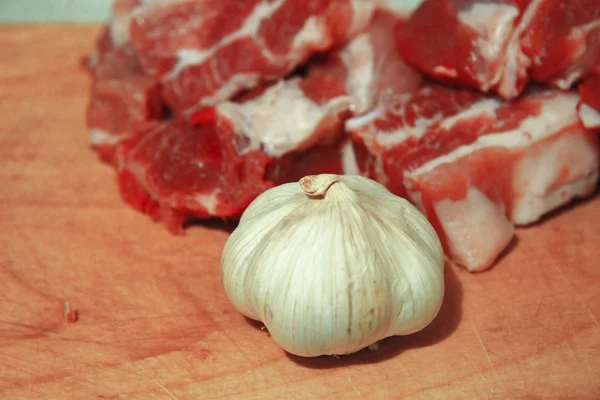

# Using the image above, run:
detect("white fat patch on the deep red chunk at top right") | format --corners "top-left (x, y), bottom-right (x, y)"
top-left (458, 2), bottom-right (519, 91)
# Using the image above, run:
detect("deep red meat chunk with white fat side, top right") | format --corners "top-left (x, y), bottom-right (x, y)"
top-left (397, 0), bottom-right (522, 97)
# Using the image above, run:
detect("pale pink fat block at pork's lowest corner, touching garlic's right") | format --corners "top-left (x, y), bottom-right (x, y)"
top-left (434, 187), bottom-right (514, 271)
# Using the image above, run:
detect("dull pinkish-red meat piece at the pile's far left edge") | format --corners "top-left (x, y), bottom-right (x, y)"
top-left (86, 30), bottom-right (164, 163)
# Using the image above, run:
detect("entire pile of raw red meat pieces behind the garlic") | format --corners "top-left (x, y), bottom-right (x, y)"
top-left (87, 0), bottom-right (600, 271)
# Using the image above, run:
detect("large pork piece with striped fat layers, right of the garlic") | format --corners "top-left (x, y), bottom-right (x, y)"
top-left (346, 85), bottom-right (599, 271)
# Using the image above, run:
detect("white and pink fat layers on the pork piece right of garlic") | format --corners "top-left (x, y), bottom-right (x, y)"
top-left (404, 92), bottom-right (599, 270)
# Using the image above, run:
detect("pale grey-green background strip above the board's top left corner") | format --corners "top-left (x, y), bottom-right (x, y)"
top-left (0, 0), bottom-right (111, 24)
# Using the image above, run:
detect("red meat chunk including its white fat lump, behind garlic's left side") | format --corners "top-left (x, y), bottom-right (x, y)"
top-left (112, 33), bottom-right (384, 232)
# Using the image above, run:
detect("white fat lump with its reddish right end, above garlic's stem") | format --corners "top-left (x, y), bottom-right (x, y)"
top-left (216, 73), bottom-right (352, 157)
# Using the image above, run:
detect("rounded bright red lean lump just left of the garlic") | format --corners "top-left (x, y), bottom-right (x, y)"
top-left (118, 118), bottom-right (272, 232)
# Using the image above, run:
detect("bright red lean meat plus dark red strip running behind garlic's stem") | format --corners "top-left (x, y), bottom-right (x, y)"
top-left (118, 111), bottom-right (364, 234)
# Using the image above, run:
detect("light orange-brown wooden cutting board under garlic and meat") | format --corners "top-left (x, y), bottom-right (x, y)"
top-left (0, 26), bottom-right (600, 400)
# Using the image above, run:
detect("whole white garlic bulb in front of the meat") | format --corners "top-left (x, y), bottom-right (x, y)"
top-left (221, 174), bottom-right (444, 357)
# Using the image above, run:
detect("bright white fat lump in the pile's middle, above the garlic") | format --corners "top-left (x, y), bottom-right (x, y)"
top-left (217, 78), bottom-right (352, 157)
